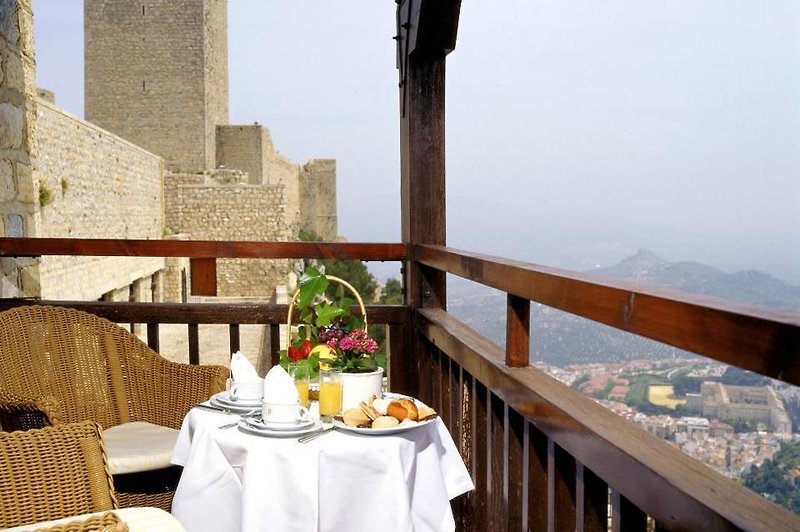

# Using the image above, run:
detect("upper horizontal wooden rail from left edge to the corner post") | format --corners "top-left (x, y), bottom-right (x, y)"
top-left (0, 237), bottom-right (406, 261)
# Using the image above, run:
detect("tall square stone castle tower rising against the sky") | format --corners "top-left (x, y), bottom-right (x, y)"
top-left (84, 0), bottom-right (228, 172)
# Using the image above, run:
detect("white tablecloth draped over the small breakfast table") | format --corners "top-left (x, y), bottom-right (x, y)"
top-left (172, 409), bottom-right (474, 532)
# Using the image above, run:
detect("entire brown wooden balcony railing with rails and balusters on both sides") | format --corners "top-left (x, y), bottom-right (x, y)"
top-left (0, 238), bottom-right (800, 531)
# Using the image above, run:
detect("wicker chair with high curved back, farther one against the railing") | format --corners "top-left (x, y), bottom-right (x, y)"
top-left (0, 305), bottom-right (229, 511)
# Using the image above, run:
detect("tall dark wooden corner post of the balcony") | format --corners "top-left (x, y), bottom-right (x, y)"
top-left (396, 0), bottom-right (461, 394)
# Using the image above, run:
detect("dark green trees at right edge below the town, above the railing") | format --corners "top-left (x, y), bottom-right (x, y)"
top-left (742, 442), bottom-right (800, 513)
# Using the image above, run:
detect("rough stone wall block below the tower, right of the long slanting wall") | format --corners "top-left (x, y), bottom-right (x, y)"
top-left (164, 174), bottom-right (293, 299)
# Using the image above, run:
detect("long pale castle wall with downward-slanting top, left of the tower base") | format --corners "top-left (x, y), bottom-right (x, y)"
top-left (34, 100), bottom-right (164, 301)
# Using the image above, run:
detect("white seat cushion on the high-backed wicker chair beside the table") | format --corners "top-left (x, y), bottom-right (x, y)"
top-left (103, 421), bottom-right (178, 475)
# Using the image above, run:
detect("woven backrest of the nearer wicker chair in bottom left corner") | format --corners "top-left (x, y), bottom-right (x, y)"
top-left (0, 421), bottom-right (118, 528)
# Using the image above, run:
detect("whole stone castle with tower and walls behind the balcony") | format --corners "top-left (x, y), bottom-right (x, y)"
top-left (0, 0), bottom-right (339, 301)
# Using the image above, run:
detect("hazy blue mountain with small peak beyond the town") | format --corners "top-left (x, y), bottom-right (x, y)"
top-left (448, 250), bottom-right (800, 366)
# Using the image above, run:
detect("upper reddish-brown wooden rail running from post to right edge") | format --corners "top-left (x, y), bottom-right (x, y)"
top-left (410, 245), bottom-right (800, 385)
